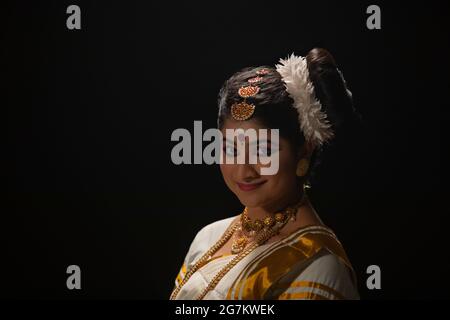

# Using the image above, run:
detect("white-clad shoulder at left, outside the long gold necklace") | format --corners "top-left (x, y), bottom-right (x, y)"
top-left (185, 217), bottom-right (235, 268)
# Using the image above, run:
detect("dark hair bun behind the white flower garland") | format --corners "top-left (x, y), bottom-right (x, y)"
top-left (306, 48), bottom-right (359, 136)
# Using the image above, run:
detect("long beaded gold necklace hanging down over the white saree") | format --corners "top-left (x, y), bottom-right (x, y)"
top-left (170, 194), bottom-right (305, 300)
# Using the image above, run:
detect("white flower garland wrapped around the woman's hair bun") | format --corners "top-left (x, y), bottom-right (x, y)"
top-left (276, 54), bottom-right (334, 147)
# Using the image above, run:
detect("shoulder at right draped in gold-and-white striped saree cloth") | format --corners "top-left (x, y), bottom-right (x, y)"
top-left (230, 226), bottom-right (358, 299)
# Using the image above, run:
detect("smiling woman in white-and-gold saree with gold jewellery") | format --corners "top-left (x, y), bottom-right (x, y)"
top-left (171, 49), bottom-right (359, 299)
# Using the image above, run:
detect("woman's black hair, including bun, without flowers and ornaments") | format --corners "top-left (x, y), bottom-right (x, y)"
top-left (217, 48), bottom-right (360, 182)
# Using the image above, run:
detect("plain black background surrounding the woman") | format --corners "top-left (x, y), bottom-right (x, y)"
top-left (0, 1), bottom-right (450, 299)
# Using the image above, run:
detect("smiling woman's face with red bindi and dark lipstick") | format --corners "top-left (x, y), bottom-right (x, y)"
top-left (220, 119), bottom-right (300, 207)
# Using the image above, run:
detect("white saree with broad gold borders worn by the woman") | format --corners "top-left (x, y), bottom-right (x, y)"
top-left (175, 217), bottom-right (359, 300)
